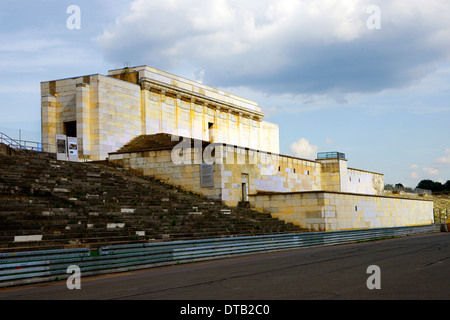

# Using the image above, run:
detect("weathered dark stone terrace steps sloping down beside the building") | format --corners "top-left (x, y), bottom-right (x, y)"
top-left (0, 150), bottom-right (304, 252)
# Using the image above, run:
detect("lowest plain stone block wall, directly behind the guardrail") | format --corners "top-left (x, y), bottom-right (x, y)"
top-left (249, 191), bottom-right (433, 231)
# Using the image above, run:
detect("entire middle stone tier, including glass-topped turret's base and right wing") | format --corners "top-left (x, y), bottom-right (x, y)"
top-left (109, 135), bottom-right (384, 205)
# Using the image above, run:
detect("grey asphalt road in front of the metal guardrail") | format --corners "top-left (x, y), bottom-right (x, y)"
top-left (0, 233), bottom-right (450, 302)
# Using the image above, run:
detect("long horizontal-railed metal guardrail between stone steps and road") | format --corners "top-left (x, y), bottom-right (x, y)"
top-left (0, 224), bottom-right (447, 287)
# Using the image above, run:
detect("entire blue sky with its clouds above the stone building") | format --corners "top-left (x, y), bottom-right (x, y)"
top-left (0, 0), bottom-right (450, 187)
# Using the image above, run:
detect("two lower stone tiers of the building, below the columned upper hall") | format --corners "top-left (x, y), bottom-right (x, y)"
top-left (109, 137), bottom-right (433, 231)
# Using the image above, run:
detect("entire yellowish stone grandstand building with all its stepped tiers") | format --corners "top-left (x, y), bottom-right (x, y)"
top-left (41, 66), bottom-right (433, 230)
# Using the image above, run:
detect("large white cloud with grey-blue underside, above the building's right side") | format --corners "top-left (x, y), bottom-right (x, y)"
top-left (97, 0), bottom-right (450, 99)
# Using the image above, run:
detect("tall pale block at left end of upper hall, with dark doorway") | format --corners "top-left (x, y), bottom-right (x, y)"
top-left (41, 75), bottom-right (141, 160)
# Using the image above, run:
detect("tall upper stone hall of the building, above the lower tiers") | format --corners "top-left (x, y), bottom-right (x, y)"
top-left (41, 66), bottom-right (279, 160)
